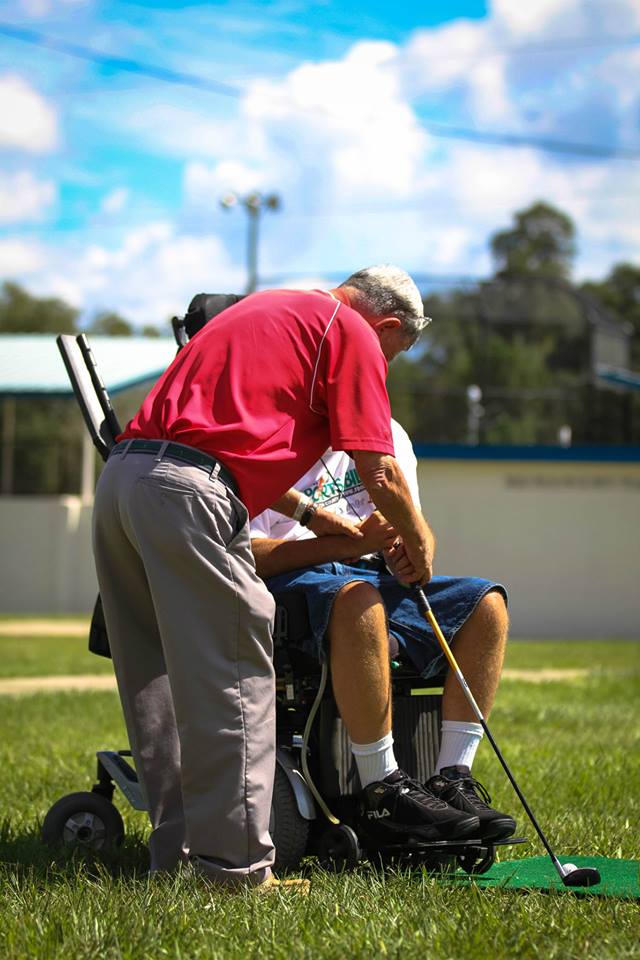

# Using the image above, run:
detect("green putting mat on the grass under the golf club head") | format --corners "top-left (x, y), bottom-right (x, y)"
top-left (453, 857), bottom-right (640, 900)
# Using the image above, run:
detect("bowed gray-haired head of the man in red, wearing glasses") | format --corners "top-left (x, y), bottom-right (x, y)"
top-left (340, 263), bottom-right (430, 340)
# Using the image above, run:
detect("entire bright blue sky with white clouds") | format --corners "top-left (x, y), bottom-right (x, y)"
top-left (0, 0), bottom-right (640, 324)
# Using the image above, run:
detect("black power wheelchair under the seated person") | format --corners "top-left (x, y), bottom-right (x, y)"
top-left (42, 294), bottom-right (518, 873)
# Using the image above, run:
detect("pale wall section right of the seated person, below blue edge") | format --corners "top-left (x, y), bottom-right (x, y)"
top-left (418, 460), bottom-right (640, 638)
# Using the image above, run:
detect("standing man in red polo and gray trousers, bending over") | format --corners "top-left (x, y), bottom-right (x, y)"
top-left (94, 266), bottom-right (468, 885)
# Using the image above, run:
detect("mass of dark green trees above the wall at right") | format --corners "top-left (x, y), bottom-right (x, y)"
top-left (413, 203), bottom-right (640, 444)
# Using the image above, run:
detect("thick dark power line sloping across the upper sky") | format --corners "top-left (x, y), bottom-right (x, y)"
top-left (0, 22), bottom-right (640, 160)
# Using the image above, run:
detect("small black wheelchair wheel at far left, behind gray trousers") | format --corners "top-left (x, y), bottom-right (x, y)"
top-left (41, 792), bottom-right (124, 852)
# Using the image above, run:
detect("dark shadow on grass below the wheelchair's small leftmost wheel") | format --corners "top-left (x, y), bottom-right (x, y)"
top-left (0, 819), bottom-right (149, 883)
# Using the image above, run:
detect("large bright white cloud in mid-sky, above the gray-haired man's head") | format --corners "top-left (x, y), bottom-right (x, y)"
top-left (243, 42), bottom-right (429, 201)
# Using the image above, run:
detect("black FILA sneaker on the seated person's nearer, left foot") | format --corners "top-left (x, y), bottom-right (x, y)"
top-left (360, 770), bottom-right (480, 843)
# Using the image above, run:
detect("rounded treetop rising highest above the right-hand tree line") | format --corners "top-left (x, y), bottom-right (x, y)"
top-left (491, 201), bottom-right (575, 279)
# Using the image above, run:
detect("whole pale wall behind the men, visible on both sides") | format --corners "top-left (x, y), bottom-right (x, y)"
top-left (0, 459), bottom-right (640, 638)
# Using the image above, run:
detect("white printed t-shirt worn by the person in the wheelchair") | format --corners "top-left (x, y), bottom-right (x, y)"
top-left (251, 420), bottom-right (421, 540)
